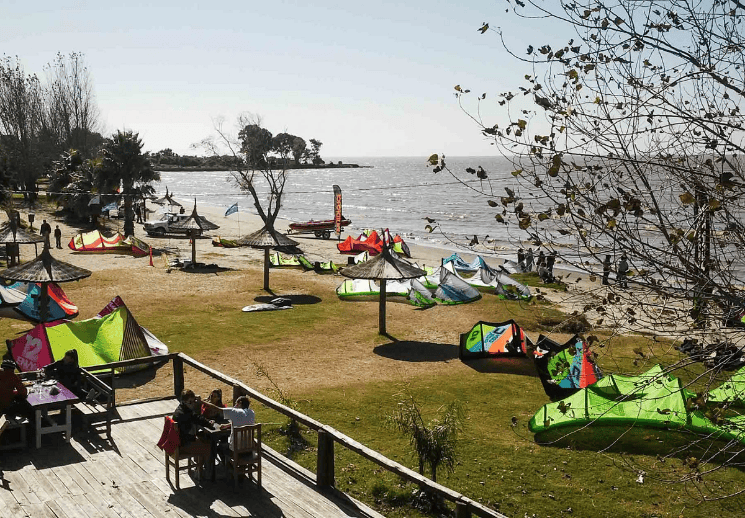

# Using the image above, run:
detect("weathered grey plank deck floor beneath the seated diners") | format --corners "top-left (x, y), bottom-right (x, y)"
top-left (0, 399), bottom-right (382, 518)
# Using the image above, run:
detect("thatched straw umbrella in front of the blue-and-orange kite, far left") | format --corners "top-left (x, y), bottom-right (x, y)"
top-left (0, 241), bottom-right (91, 322)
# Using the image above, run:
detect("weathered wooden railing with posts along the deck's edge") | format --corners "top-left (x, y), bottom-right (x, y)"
top-left (88, 353), bottom-right (506, 518)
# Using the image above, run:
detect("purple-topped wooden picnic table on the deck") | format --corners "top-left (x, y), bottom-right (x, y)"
top-left (26, 380), bottom-right (80, 448)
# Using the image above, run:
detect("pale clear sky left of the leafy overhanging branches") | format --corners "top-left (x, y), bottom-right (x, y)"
top-left (0, 0), bottom-right (552, 158)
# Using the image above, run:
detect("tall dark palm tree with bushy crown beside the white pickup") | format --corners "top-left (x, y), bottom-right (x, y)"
top-left (98, 130), bottom-right (160, 236)
